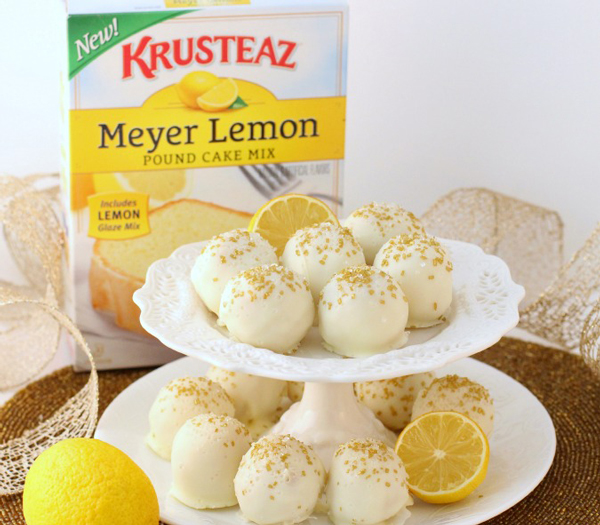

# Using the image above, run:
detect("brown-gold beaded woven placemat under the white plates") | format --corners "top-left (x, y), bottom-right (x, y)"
top-left (0, 338), bottom-right (600, 525)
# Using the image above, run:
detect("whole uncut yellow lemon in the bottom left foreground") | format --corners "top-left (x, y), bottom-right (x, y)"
top-left (23, 438), bottom-right (159, 525)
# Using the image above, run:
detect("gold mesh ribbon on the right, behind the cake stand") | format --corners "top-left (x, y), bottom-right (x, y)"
top-left (423, 188), bottom-right (600, 369)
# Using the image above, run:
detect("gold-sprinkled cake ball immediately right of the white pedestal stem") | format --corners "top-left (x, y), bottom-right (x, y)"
top-left (354, 372), bottom-right (435, 432)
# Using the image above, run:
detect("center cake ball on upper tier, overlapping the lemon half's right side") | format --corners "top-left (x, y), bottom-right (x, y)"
top-left (281, 222), bottom-right (365, 303)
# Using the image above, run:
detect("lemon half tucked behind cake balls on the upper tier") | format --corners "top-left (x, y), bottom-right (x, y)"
top-left (248, 193), bottom-right (339, 255)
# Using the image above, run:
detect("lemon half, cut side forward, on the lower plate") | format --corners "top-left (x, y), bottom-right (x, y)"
top-left (396, 412), bottom-right (490, 503)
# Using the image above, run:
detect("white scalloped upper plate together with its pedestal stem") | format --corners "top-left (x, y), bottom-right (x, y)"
top-left (133, 240), bottom-right (524, 467)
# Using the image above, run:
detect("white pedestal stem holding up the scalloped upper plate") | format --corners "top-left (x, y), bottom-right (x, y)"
top-left (270, 383), bottom-right (396, 470)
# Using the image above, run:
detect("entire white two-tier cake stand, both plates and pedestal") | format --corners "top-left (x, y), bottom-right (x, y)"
top-left (96, 241), bottom-right (555, 525)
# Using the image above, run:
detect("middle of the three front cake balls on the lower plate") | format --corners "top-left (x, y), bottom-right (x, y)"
top-left (234, 435), bottom-right (325, 525)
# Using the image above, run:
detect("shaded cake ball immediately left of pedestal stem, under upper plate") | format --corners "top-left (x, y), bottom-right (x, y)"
top-left (206, 366), bottom-right (288, 424)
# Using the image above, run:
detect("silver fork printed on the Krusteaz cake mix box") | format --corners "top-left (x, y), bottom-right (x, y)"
top-left (239, 164), bottom-right (342, 205)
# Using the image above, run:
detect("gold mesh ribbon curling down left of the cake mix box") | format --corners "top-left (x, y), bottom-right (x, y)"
top-left (0, 176), bottom-right (98, 495)
